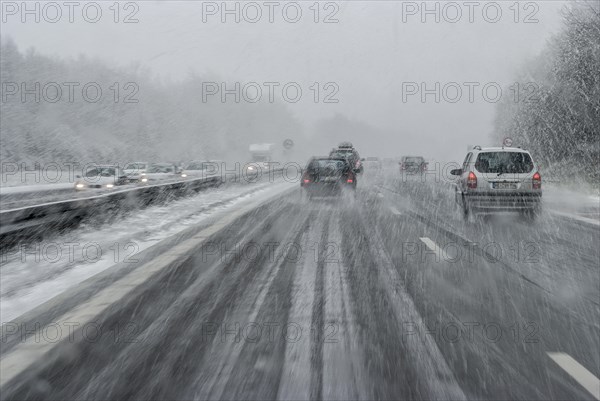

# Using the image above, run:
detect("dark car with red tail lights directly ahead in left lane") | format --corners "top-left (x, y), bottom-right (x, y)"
top-left (300, 157), bottom-right (356, 198)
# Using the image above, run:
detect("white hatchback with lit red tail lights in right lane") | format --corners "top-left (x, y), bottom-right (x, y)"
top-left (450, 146), bottom-right (542, 218)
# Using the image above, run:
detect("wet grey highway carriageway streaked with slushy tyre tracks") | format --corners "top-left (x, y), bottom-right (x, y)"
top-left (0, 175), bottom-right (600, 400)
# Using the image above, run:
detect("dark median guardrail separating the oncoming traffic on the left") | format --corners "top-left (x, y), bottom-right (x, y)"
top-left (0, 170), bottom-right (282, 247)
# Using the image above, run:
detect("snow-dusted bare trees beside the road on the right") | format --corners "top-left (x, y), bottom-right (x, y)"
top-left (494, 1), bottom-right (600, 186)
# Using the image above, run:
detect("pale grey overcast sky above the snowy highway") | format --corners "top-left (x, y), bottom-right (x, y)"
top-left (1, 1), bottom-right (564, 160)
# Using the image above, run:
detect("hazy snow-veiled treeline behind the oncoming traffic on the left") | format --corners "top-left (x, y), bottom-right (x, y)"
top-left (0, 39), bottom-right (302, 163)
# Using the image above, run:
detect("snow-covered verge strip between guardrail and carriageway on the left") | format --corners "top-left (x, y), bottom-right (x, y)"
top-left (0, 182), bottom-right (293, 322)
